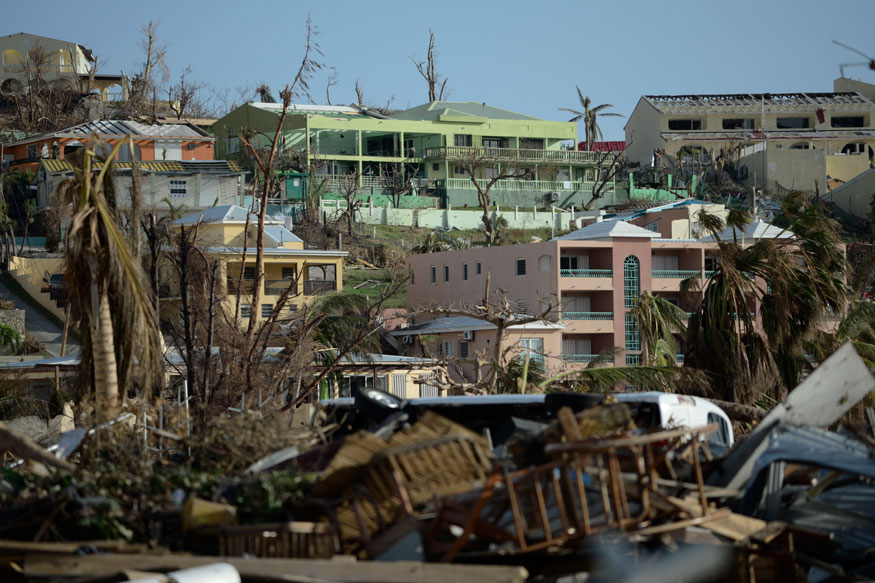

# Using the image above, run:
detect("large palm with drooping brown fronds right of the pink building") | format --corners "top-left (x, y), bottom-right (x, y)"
top-left (684, 195), bottom-right (849, 404)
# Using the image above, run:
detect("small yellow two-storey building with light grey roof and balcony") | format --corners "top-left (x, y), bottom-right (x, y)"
top-left (169, 205), bottom-right (347, 319)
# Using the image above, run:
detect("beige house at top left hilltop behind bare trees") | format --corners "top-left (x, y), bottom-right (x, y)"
top-left (0, 32), bottom-right (124, 100)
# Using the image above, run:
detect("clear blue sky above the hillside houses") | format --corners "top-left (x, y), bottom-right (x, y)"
top-left (0, 0), bottom-right (875, 140)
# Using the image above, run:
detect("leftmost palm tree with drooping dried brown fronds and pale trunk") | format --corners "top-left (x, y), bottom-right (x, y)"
top-left (61, 136), bottom-right (162, 418)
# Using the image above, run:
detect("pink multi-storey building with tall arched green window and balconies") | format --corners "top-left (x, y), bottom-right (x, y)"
top-left (393, 201), bottom-right (816, 372)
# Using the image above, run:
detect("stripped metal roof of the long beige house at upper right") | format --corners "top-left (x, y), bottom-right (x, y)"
top-left (643, 92), bottom-right (875, 113)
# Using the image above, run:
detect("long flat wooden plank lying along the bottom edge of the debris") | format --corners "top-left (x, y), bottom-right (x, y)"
top-left (24, 553), bottom-right (528, 583)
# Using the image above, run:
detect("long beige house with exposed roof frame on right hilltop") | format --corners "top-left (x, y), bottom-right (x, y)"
top-left (625, 91), bottom-right (875, 193)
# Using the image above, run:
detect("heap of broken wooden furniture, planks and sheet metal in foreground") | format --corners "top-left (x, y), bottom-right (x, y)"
top-left (0, 347), bottom-right (875, 583)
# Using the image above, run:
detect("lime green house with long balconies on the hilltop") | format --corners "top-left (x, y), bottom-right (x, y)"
top-left (213, 101), bottom-right (614, 208)
